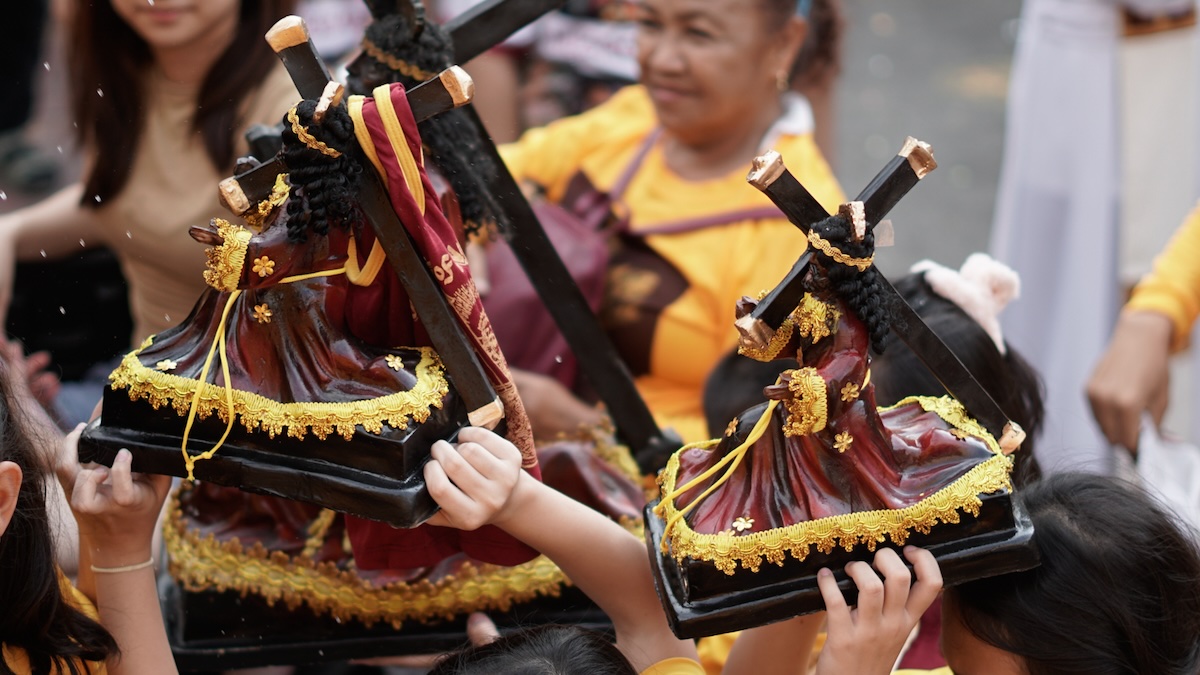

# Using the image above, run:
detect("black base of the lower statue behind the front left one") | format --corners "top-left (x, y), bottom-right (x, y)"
top-left (158, 566), bottom-right (612, 671)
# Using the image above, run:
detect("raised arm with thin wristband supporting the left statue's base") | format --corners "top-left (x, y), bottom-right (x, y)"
top-left (67, 430), bottom-right (176, 675)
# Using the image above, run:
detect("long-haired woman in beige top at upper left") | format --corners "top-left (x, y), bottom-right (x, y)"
top-left (0, 0), bottom-right (300, 345)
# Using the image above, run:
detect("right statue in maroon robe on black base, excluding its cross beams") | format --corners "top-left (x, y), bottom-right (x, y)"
top-left (646, 141), bottom-right (1037, 638)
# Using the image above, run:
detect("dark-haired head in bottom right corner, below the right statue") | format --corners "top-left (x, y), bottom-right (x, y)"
top-left (947, 473), bottom-right (1200, 675)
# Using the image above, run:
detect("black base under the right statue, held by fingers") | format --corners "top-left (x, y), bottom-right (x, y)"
top-left (646, 491), bottom-right (1038, 639)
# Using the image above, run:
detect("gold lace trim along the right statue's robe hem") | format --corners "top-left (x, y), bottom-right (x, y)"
top-left (654, 396), bottom-right (1013, 574)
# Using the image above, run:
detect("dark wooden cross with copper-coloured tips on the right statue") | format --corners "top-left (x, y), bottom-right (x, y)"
top-left (738, 144), bottom-right (1025, 453)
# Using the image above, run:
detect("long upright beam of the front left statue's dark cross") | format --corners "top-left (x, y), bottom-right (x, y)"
top-left (255, 17), bottom-right (504, 428)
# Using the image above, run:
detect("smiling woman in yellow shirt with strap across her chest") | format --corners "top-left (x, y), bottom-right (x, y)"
top-left (503, 0), bottom-right (842, 441)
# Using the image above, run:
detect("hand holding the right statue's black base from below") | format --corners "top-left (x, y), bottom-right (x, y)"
top-left (817, 546), bottom-right (942, 675)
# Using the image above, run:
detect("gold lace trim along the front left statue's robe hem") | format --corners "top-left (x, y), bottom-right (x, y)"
top-left (108, 338), bottom-right (449, 441)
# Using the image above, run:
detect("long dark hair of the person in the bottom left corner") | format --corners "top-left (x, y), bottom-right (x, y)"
top-left (0, 364), bottom-right (120, 675)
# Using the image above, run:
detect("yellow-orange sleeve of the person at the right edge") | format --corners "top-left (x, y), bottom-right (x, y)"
top-left (1126, 198), bottom-right (1200, 351)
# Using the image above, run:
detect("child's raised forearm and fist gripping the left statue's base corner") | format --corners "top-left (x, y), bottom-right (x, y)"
top-left (425, 429), bottom-right (696, 671)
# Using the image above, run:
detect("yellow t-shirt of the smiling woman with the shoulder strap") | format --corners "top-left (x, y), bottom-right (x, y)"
top-left (502, 85), bottom-right (844, 442)
